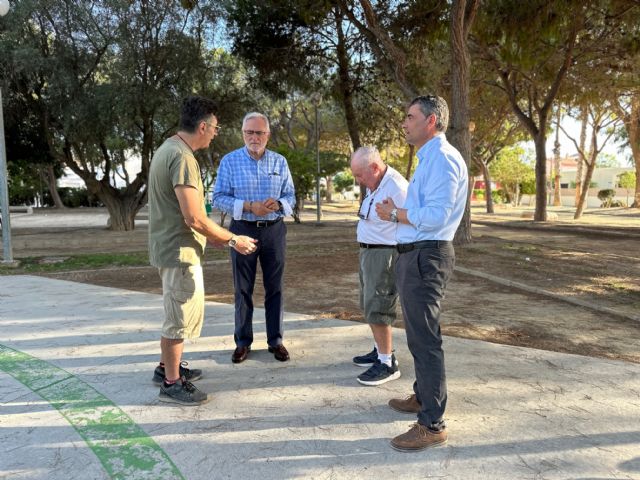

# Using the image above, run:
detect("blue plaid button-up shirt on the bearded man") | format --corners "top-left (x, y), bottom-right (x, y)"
top-left (213, 147), bottom-right (296, 221)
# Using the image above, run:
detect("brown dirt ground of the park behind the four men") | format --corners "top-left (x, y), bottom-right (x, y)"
top-left (5, 206), bottom-right (640, 363)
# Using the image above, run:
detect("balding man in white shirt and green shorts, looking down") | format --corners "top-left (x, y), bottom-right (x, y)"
top-left (351, 147), bottom-right (408, 385)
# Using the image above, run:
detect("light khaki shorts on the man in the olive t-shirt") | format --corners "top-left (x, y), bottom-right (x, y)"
top-left (158, 265), bottom-right (204, 339)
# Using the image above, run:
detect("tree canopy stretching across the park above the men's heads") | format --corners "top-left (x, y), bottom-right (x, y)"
top-left (0, 0), bottom-right (640, 232)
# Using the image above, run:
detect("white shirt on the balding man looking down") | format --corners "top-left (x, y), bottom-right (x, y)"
top-left (357, 165), bottom-right (409, 245)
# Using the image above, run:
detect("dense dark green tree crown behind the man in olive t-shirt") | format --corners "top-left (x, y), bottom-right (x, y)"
top-left (0, 0), bottom-right (226, 228)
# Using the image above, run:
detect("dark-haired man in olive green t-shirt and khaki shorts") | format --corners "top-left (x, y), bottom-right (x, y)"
top-left (148, 96), bottom-right (256, 405)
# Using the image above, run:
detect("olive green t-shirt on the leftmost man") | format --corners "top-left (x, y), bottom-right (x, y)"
top-left (148, 138), bottom-right (206, 268)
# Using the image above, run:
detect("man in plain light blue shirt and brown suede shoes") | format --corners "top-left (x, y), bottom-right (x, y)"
top-left (376, 95), bottom-right (469, 451)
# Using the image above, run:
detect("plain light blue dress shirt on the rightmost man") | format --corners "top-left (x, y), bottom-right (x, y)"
top-left (396, 133), bottom-right (469, 243)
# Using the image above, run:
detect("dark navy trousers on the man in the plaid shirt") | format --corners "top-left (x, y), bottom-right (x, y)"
top-left (229, 220), bottom-right (287, 347)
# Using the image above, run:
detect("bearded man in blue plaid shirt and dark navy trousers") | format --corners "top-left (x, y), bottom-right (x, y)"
top-left (213, 112), bottom-right (295, 363)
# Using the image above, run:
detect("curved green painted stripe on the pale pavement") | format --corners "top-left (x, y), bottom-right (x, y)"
top-left (0, 345), bottom-right (184, 480)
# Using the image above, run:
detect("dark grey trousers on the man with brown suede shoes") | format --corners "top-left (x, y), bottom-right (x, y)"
top-left (396, 242), bottom-right (455, 426)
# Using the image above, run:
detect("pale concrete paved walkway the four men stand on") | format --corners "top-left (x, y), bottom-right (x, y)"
top-left (0, 276), bottom-right (640, 480)
